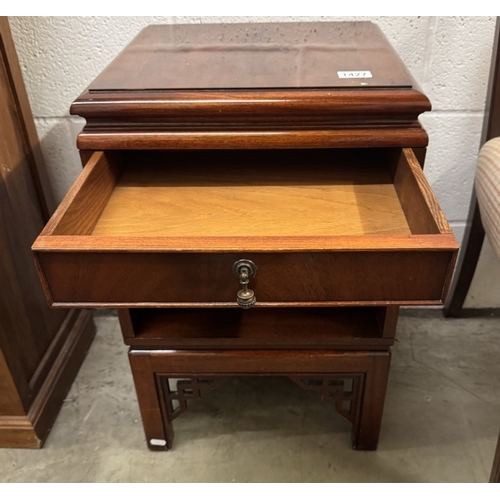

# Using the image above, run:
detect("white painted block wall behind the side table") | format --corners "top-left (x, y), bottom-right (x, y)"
top-left (9, 17), bottom-right (500, 307)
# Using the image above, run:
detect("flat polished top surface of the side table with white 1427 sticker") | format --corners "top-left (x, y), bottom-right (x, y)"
top-left (89, 22), bottom-right (413, 92)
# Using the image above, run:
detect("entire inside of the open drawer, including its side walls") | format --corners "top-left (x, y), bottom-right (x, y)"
top-left (52, 148), bottom-right (449, 238)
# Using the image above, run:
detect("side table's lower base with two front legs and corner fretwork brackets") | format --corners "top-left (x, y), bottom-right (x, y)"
top-left (129, 350), bottom-right (390, 450)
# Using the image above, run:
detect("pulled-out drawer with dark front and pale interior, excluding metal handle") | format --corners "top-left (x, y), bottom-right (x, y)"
top-left (33, 148), bottom-right (457, 307)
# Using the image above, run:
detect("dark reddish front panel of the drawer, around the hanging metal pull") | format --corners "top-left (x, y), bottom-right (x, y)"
top-left (38, 251), bottom-right (453, 307)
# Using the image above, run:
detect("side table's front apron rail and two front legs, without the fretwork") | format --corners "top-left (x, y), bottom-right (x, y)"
top-left (129, 349), bottom-right (391, 450)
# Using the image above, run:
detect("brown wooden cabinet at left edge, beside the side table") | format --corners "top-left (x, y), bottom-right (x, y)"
top-left (0, 18), bottom-right (95, 448)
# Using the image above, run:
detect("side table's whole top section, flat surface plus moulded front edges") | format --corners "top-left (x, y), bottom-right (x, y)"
top-left (71, 22), bottom-right (431, 150)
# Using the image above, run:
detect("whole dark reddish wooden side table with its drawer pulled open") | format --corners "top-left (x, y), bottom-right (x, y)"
top-left (33, 22), bottom-right (457, 449)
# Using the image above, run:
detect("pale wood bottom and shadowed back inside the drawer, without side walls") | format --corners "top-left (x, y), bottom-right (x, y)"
top-left (92, 150), bottom-right (410, 237)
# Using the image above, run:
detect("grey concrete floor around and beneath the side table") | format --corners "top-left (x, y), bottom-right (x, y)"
top-left (0, 309), bottom-right (500, 482)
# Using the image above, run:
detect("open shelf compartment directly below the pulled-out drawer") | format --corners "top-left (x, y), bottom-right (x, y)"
top-left (119, 307), bottom-right (397, 350)
